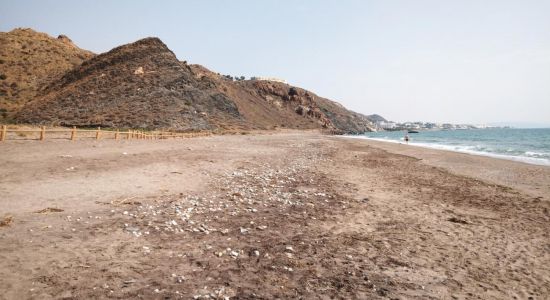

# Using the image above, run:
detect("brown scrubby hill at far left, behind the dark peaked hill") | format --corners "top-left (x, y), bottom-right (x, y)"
top-left (0, 28), bottom-right (94, 121)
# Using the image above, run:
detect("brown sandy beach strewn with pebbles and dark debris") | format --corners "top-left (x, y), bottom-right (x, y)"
top-left (0, 132), bottom-right (550, 299)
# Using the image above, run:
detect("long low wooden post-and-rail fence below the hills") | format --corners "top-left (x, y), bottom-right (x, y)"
top-left (0, 125), bottom-right (212, 142)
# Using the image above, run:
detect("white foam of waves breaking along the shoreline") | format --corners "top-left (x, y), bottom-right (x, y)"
top-left (342, 135), bottom-right (550, 166)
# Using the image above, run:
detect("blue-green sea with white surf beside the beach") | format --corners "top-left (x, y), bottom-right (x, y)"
top-left (352, 128), bottom-right (550, 166)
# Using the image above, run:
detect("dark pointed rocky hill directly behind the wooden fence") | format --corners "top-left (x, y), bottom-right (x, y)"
top-left (17, 38), bottom-right (250, 130)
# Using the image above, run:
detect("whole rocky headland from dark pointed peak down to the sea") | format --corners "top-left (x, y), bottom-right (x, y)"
top-left (15, 31), bottom-right (380, 133)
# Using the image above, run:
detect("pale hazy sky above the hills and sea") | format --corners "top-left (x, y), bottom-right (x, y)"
top-left (0, 0), bottom-right (550, 124)
